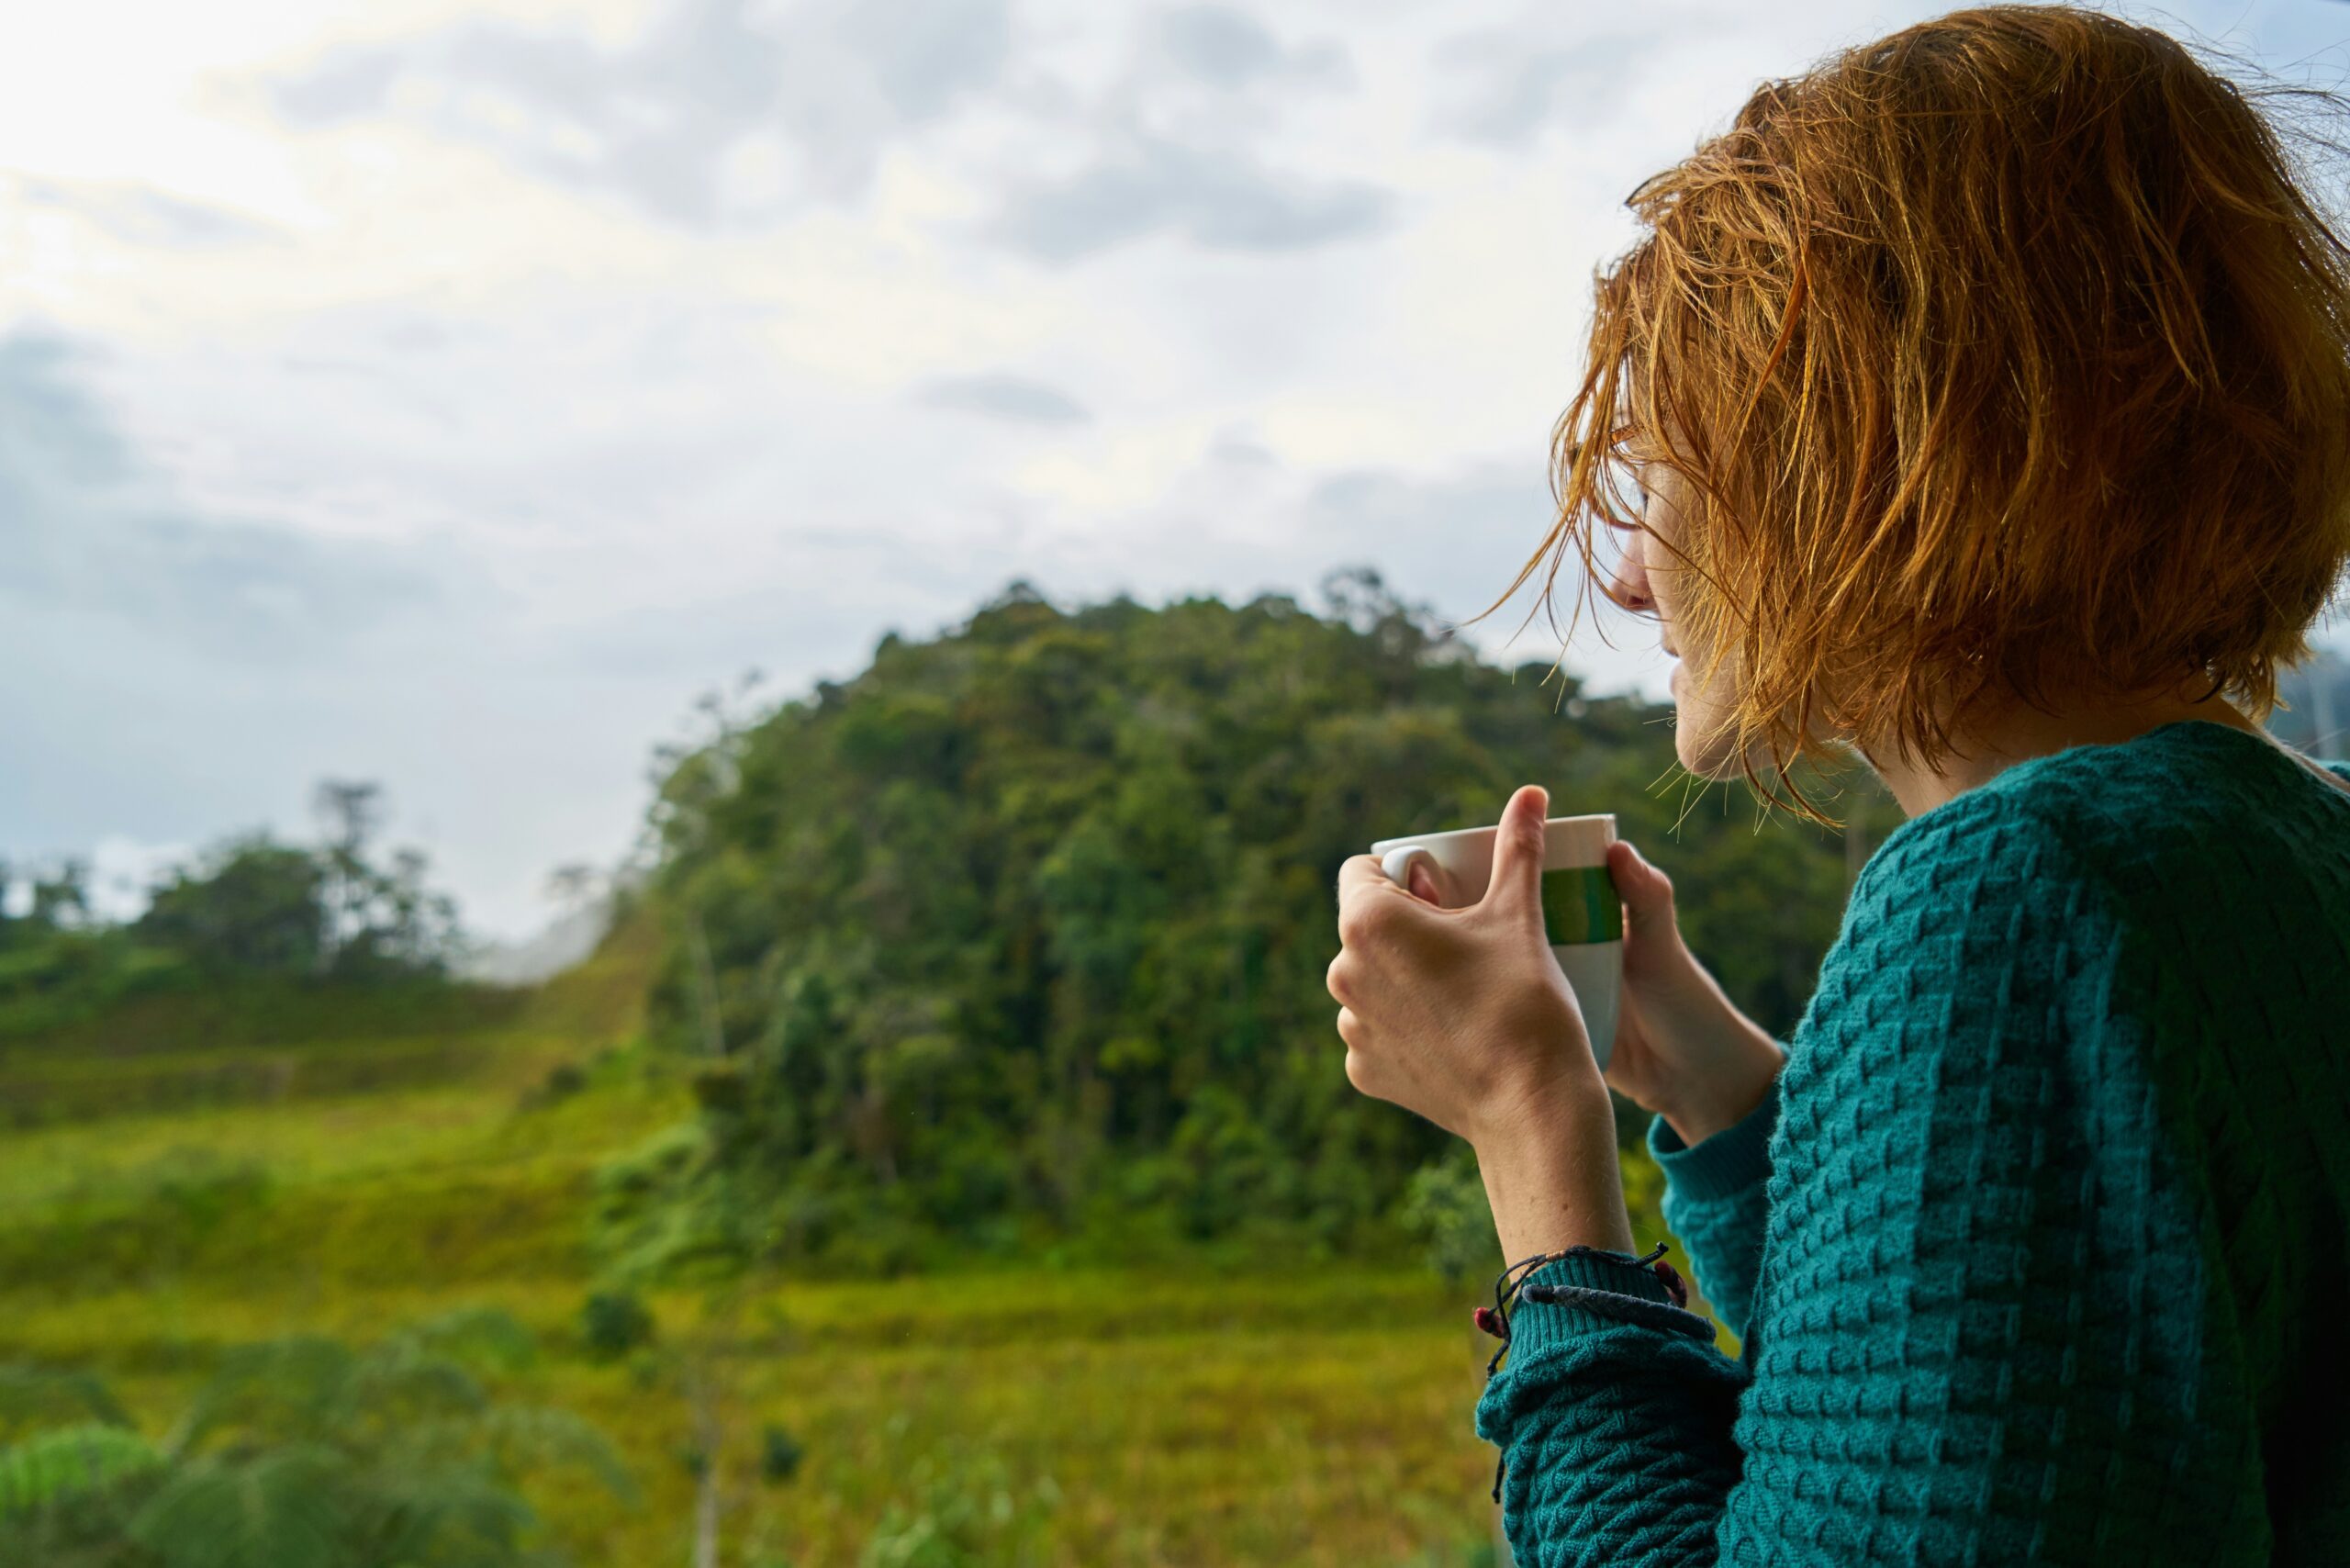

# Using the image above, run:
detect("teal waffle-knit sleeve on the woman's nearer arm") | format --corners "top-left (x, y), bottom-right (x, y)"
top-left (1476, 813), bottom-right (2266, 1568)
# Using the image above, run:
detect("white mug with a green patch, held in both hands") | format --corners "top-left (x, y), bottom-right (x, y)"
top-left (1370, 816), bottom-right (1624, 1072)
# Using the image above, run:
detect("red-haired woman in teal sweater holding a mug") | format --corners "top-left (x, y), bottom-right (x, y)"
top-left (1330, 7), bottom-right (2350, 1568)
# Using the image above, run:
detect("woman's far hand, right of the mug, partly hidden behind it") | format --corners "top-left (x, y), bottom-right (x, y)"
top-left (1607, 839), bottom-right (1786, 1145)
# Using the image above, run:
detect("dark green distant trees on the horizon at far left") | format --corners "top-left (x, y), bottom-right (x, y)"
top-left (0, 780), bottom-right (463, 1035)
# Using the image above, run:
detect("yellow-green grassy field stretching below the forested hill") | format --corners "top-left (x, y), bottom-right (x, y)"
top-left (0, 925), bottom-right (1692, 1568)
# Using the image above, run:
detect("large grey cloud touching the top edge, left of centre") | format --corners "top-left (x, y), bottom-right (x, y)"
top-left (270, 0), bottom-right (1011, 228)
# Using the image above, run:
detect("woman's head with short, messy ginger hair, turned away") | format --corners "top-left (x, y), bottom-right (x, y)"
top-left (1514, 5), bottom-right (2350, 813)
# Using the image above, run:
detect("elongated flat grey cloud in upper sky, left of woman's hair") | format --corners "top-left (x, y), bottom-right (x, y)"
top-left (991, 134), bottom-right (1393, 261)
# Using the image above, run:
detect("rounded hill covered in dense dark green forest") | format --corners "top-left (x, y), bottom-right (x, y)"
top-left (649, 574), bottom-right (1847, 1250)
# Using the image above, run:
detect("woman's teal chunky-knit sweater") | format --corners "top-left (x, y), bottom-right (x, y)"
top-left (1476, 720), bottom-right (2350, 1568)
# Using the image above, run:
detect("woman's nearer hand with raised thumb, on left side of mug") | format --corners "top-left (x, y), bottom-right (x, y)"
top-left (1330, 785), bottom-right (1607, 1148)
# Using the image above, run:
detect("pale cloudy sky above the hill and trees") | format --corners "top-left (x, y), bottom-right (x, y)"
top-left (0, 0), bottom-right (2350, 938)
